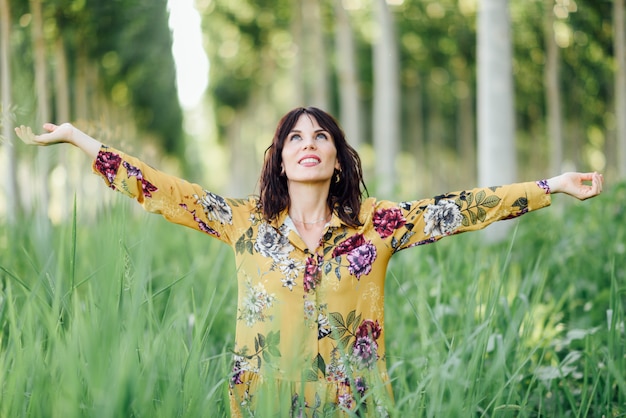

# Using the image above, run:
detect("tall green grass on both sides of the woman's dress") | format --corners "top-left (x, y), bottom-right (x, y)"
top-left (0, 185), bottom-right (626, 418)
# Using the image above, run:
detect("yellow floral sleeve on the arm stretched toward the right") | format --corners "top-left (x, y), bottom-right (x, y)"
top-left (372, 182), bottom-right (551, 252)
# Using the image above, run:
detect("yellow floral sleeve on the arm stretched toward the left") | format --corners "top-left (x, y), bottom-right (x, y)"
top-left (93, 145), bottom-right (249, 243)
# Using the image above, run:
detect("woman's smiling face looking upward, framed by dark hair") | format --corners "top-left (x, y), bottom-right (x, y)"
top-left (282, 114), bottom-right (340, 184)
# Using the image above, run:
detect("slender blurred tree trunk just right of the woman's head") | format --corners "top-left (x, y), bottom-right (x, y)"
top-left (334, 1), bottom-right (363, 149)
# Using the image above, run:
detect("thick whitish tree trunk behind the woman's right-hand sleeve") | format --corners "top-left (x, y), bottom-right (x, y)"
top-left (477, 0), bottom-right (517, 240)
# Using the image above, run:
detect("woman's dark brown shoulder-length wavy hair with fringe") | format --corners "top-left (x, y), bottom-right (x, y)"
top-left (259, 107), bottom-right (367, 227)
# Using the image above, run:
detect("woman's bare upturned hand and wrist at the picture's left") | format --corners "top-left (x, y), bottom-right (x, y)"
top-left (15, 123), bottom-right (102, 159)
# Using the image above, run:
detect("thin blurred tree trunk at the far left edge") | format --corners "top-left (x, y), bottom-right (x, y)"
top-left (0, 0), bottom-right (20, 224)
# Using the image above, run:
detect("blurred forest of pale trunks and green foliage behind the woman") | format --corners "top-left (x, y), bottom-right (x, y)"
top-left (0, 0), bottom-right (626, 225)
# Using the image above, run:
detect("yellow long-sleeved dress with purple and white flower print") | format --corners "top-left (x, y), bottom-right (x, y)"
top-left (93, 146), bottom-right (550, 416)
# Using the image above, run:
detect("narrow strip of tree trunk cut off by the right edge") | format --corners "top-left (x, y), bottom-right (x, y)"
top-left (613, 0), bottom-right (626, 179)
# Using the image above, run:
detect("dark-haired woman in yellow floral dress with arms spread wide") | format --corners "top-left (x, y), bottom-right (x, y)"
top-left (16, 107), bottom-right (603, 416)
